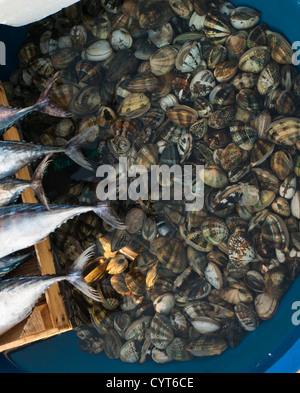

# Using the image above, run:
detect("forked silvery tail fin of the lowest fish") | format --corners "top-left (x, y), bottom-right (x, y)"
top-left (66, 246), bottom-right (101, 302)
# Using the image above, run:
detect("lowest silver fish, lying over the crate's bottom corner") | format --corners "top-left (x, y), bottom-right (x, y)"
top-left (0, 246), bottom-right (100, 335)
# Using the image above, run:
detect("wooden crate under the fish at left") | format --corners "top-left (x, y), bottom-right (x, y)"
top-left (0, 82), bottom-right (72, 352)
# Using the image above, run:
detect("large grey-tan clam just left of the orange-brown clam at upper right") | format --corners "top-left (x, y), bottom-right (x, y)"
top-left (239, 46), bottom-right (271, 74)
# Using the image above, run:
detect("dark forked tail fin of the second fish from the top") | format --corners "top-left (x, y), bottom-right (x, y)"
top-left (64, 126), bottom-right (99, 171)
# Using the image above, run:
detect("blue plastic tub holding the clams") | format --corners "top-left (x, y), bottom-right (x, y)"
top-left (0, 0), bottom-right (300, 374)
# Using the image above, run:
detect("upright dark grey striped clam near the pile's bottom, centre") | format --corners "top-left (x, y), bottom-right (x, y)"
top-left (149, 314), bottom-right (174, 349)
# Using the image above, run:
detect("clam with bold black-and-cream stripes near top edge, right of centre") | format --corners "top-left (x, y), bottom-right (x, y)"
top-left (204, 12), bottom-right (231, 44)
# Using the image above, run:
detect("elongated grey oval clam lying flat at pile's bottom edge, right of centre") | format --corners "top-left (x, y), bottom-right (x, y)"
top-left (185, 335), bottom-right (228, 357)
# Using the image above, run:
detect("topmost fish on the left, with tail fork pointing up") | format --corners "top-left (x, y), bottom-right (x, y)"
top-left (0, 72), bottom-right (73, 135)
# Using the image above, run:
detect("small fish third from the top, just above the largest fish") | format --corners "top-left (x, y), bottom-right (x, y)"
top-left (0, 154), bottom-right (51, 210)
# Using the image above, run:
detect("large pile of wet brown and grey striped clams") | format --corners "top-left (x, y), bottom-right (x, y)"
top-left (4, 0), bottom-right (300, 363)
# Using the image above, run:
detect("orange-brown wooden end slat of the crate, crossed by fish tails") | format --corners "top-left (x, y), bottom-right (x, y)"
top-left (0, 82), bottom-right (72, 346)
